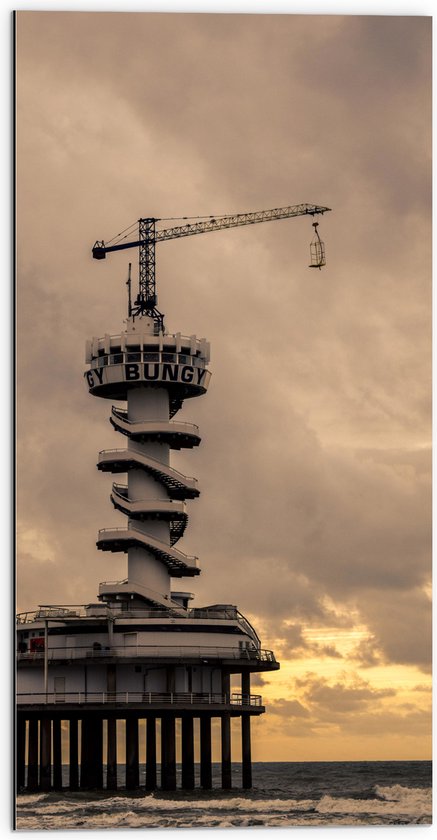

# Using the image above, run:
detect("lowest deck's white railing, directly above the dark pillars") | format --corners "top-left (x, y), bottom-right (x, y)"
top-left (17, 691), bottom-right (262, 708)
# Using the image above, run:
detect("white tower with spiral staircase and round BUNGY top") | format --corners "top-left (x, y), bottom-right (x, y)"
top-left (85, 317), bottom-right (211, 609)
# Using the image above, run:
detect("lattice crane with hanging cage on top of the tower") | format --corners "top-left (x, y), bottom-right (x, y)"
top-left (92, 204), bottom-right (331, 331)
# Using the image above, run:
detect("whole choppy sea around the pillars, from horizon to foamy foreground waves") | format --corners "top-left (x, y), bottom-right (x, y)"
top-left (16, 761), bottom-right (432, 831)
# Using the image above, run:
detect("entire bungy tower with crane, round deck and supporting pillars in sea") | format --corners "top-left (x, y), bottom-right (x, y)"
top-left (16, 200), bottom-right (329, 791)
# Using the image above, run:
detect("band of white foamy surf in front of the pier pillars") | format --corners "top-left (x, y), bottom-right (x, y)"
top-left (17, 785), bottom-right (432, 830)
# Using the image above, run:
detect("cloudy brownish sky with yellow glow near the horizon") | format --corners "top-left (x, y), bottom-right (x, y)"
top-left (17, 12), bottom-right (431, 760)
